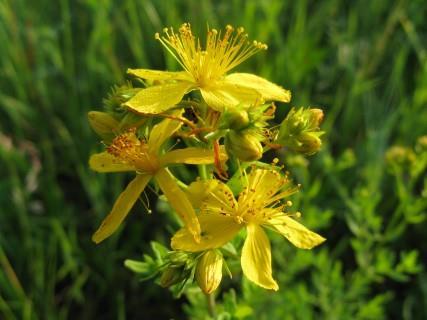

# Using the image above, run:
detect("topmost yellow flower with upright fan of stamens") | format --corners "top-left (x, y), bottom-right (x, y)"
top-left (125, 23), bottom-right (291, 114)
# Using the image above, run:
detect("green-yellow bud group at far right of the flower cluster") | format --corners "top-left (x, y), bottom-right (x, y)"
top-left (275, 108), bottom-right (323, 155)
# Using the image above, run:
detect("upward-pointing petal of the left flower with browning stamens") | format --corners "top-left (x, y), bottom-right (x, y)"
top-left (148, 109), bottom-right (184, 153)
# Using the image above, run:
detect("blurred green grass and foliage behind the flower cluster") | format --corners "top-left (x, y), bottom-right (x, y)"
top-left (0, 0), bottom-right (427, 320)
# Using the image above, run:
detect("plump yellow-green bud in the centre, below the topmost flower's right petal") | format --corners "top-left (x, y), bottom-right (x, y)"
top-left (225, 130), bottom-right (263, 161)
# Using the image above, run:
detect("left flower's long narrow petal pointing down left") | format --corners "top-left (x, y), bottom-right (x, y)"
top-left (92, 175), bottom-right (151, 243)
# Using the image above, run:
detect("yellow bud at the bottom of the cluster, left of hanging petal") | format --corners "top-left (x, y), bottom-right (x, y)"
top-left (196, 250), bottom-right (223, 294)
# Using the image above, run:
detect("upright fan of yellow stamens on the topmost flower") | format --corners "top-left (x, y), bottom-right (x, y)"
top-left (155, 23), bottom-right (267, 87)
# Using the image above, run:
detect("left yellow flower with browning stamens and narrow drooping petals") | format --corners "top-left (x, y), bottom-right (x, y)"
top-left (89, 109), bottom-right (226, 243)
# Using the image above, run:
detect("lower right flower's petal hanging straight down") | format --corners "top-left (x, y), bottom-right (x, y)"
top-left (241, 224), bottom-right (279, 291)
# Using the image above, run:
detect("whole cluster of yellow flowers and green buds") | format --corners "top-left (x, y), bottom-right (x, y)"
top-left (89, 23), bottom-right (325, 293)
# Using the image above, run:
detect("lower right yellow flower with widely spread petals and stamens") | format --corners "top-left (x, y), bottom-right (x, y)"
top-left (171, 169), bottom-right (325, 290)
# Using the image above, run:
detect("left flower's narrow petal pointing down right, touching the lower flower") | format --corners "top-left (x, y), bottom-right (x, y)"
top-left (155, 169), bottom-right (200, 241)
